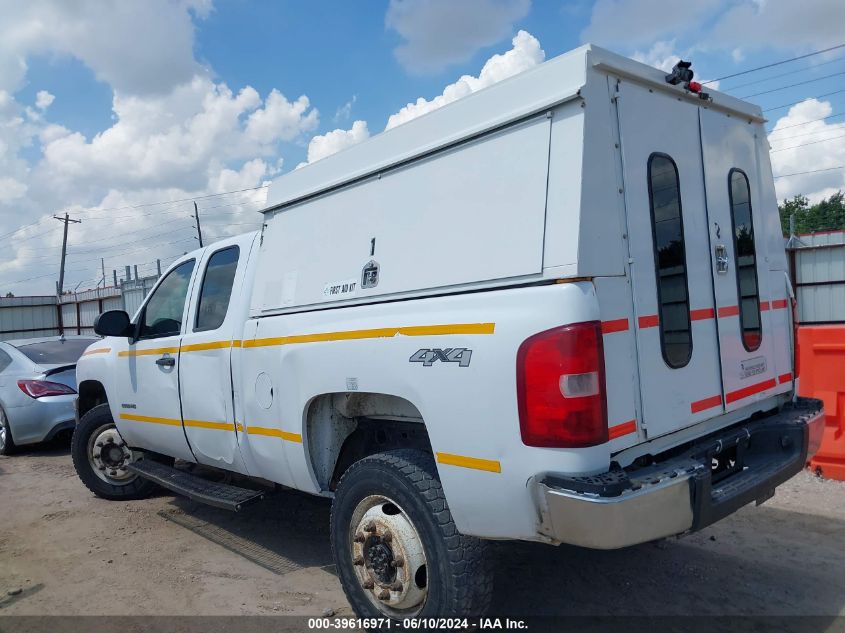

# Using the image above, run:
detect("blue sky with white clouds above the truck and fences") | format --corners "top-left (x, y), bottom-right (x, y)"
top-left (0, 0), bottom-right (845, 292)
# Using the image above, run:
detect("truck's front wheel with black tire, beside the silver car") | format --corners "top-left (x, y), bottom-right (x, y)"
top-left (70, 403), bottom-right (156, 501)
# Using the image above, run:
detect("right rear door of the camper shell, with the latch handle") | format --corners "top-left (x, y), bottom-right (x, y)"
top-left (700, 109), bottom-right (792, 411)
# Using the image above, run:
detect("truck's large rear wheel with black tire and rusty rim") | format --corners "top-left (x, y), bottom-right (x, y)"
top-left (331, 449), bottom-right (493, 621)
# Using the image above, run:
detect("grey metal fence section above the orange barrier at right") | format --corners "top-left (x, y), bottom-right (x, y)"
top-left (787, 230), bottom-right (845, 324)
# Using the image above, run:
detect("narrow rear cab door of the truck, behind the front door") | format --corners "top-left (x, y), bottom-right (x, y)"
top-left (179, 234), bottom-right (254, 474)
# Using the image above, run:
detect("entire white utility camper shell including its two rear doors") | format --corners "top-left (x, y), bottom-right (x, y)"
top-left (250, 45), bottom-right (792, 450)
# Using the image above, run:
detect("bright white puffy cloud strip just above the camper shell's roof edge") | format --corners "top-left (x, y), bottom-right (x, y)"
top-left (385, 31), bottom-right (546, 130)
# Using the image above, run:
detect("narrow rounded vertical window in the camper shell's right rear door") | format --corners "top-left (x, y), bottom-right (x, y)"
top-left (728, 168), bottom-right (763, 352)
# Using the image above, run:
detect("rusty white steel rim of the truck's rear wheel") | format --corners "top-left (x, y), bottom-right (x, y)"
top-left (349, 495), bottom-right (429, 618)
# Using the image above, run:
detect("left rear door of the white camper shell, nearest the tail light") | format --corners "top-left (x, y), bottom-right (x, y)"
top-left (611, 81), bottom-right (724, 438)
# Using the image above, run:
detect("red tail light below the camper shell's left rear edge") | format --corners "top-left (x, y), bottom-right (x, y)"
top-left (516, 321), bottom-right (608, 448)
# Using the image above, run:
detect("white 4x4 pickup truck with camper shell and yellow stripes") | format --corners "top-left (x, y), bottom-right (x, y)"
top-left (72, 46), bottom-right (822, 619)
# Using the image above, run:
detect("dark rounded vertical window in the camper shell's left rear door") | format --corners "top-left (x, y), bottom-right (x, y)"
top-left (648, 153), bottom-right (692, 369)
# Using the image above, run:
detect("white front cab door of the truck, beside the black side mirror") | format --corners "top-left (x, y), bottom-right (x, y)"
top-left (112, 258), bottom-right (196, 461)
